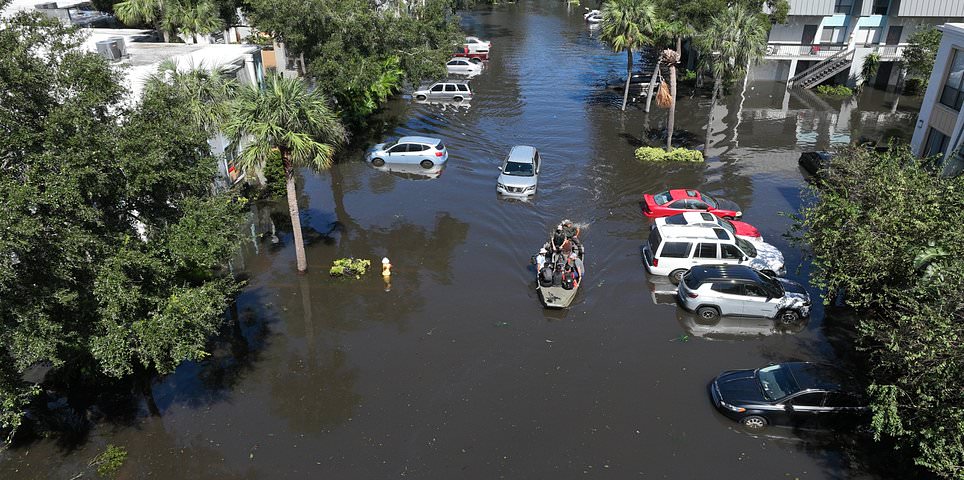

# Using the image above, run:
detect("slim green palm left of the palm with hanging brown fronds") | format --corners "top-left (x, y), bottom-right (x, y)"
top-left (599, 0), bottom-right (655, 110)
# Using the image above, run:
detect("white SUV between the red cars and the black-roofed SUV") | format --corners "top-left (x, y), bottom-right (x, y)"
top-left (643, 224), bottom-right (786, 284)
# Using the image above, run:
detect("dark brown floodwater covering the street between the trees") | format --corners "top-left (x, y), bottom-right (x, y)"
top-left (0, 0), bottom-right (917, 479)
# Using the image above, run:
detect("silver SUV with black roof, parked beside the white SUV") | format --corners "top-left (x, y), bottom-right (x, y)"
top-left (677, 265), bottom-right (810, 326)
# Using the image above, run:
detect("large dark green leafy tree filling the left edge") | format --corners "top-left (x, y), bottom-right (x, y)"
top-left (0, 10), bottom-right (240, 436)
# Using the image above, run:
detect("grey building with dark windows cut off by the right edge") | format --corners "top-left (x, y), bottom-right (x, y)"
top-left (911, 23), bottom-right (964, 176)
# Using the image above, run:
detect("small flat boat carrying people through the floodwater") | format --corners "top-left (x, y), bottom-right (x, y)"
top-left (533, 223), bottom-right (586, 308)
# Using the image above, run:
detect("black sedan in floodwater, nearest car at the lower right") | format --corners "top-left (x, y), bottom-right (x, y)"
top-left (710, 362), bottom-right (868, 429)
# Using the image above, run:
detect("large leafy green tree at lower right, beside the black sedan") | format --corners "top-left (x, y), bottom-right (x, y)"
top-left (797, 147), bottom-right (964, 478)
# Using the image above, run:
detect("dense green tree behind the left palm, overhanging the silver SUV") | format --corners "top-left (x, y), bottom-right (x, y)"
top-left (248, 0), bottom-right (462, 123)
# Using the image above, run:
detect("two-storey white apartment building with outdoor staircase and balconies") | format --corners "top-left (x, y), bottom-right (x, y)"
top-left (754, 0), bottom-right (964, 88)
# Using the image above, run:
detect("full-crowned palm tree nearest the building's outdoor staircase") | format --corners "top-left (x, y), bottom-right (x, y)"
top-left (696, 4), bottom-right (769, 155)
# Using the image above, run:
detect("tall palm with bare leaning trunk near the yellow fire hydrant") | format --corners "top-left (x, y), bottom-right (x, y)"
top-left (224, 74), bottom-right (347, 273)
